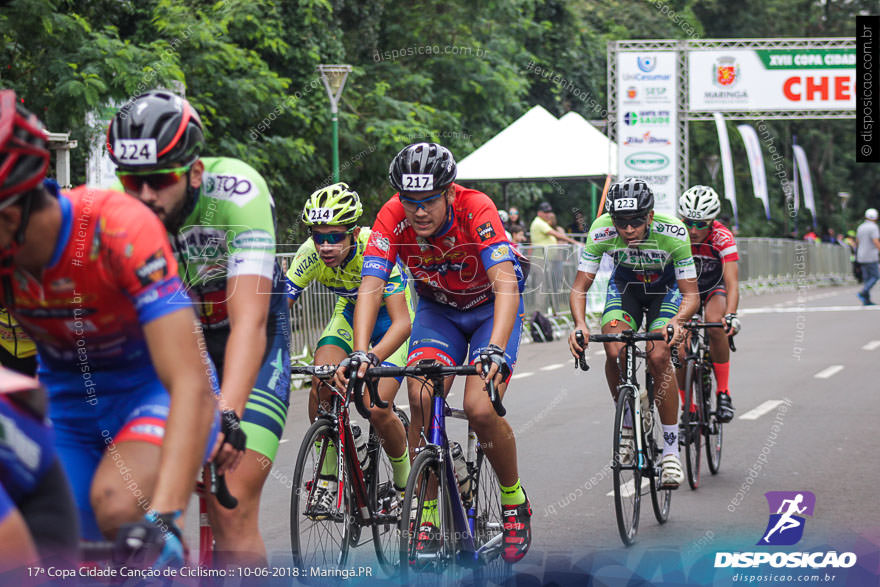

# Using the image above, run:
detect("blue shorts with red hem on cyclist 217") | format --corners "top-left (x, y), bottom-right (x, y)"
top-left (407, 296), bottom-right (525, 380)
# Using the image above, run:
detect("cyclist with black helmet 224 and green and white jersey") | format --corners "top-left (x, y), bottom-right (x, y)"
top-left (107, 90), bottom-right (290, 565)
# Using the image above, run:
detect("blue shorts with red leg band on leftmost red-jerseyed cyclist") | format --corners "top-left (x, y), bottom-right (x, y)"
top-left (43, 373), bottom-right (220, 540)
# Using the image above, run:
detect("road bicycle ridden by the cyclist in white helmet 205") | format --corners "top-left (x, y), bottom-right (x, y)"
top-left (679, 316), bottom-right (736, 489)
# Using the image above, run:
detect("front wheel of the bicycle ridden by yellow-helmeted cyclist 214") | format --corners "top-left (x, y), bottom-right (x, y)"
top-left (290, 418), bottom-right (352, 569)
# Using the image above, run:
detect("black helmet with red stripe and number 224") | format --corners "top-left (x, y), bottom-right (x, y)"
top-left (107, 90), bottom-right (205, 171)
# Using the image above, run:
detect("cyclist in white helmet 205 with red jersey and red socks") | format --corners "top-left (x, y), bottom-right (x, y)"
top-left (678, 185), bottom-right (741, 422)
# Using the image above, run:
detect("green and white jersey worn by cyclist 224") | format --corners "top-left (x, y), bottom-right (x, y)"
top-left (171, 157), bottom-right (286, 331)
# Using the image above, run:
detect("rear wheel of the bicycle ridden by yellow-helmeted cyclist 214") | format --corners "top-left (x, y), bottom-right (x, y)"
top-left (367, 410), bottom-right (409, 576)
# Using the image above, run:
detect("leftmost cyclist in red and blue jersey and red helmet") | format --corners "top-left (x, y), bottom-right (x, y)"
top-left (0, 90), bottom-right (227, 564)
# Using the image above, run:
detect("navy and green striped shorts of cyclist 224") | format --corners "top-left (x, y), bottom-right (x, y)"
top-left (205, 304), bottom-right (290, 461)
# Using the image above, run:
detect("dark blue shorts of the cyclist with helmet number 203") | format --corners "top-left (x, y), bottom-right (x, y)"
top-left (602, 275), bottom-right (681, 331)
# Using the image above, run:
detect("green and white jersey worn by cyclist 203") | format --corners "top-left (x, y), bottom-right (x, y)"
top-left (578, 213), bottom-right (697, 287)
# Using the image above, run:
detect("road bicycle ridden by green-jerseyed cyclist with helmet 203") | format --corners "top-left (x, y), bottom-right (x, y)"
top-left (575, 330), bottom-right (678, 546)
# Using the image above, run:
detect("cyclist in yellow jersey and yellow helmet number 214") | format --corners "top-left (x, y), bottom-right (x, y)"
top-left (287, 183), bottom-right (412, 517)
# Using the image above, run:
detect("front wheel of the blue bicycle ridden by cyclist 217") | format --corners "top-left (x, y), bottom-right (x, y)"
top-left (399, 447), bottom-right (463, 586)
